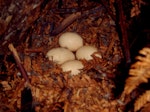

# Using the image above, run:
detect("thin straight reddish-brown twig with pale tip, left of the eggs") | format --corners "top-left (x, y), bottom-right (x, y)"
top-left (8, 44), bottom-right (29, 82)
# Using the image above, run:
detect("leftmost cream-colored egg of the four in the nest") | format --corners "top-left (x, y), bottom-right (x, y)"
top-left (46, 47), bottom-right (75, 64)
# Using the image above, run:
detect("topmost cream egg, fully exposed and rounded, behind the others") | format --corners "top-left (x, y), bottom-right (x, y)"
top-left (59, 32), bottom-right (83, 51)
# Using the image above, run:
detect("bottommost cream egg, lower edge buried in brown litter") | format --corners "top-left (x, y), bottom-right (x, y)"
top-left (61, 60), bottom-right (84, 75)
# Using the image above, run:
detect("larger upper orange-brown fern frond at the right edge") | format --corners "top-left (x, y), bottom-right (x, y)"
top-left (123, 48), bottom-right (150, 94)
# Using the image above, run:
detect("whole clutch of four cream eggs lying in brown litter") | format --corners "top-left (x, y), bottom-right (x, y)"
top-left (46, 32), bottom-right (102, 75)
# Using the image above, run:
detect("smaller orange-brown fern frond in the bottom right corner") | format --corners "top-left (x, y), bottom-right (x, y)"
top-left (134, 90), bottom-right (150, 112)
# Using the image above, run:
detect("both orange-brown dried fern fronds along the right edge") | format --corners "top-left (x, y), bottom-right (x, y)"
top-left (122, 48), bottom-right (150, 112)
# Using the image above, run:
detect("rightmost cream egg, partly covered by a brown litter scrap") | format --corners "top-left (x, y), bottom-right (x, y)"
top-left (76, 45), bottom-right (102, 60)
